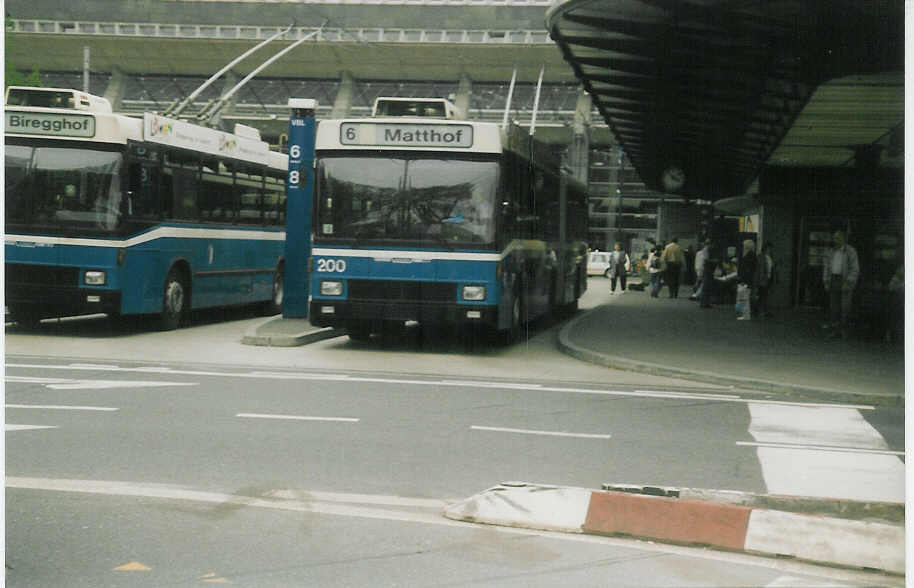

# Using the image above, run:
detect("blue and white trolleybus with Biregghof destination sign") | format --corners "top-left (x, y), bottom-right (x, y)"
top-left (5, 87), bottom-right (288, 329)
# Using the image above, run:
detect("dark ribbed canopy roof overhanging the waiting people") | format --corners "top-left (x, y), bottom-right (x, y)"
top-left (546, 0), bottom-right (904, 200)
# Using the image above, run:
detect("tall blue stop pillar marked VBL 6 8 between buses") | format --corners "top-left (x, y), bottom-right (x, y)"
top-left (282, 98), bottom-right (317, 318)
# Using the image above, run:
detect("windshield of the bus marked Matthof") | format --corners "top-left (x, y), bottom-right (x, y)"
top-left (315, 153), bottom-right (498, 247)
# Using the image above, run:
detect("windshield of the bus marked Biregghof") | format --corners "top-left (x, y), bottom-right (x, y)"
top-left (5, 144), bottom-right (123, 231)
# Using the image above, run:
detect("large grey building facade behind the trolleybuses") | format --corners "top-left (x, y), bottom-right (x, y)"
top-left (6, 0), bottom-right (668, 252)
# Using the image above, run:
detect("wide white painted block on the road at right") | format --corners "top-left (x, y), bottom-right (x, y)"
top-left (749, 404), bottom-right (905, 502)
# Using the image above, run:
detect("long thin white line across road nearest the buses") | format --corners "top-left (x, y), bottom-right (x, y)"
top-left (6, 363), bottom-right (875, 410)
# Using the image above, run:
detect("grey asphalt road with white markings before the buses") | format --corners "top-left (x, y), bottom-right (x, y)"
top-left (5, 296), bottom-right (903, 586)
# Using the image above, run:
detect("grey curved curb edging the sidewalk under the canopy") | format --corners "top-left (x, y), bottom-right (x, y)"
top-left (558, 307), bottom-right (904, 406)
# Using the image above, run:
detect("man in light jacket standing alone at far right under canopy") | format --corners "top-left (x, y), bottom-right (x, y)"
top-left (822, 229), bottom-right (860, 339)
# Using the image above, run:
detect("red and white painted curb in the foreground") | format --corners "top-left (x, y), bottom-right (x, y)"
top-left (444, 483), bottom-right (905, 574)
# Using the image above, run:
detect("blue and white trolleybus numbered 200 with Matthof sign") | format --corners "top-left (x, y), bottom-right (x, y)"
top-left (309, 98), bottom-right (587, 340)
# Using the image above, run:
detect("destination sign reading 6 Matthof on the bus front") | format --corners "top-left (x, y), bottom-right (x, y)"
top-left (340, 122), bottom-right (473, 149)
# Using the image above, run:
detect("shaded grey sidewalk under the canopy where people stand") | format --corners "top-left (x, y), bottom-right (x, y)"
top-left (559, 280), bottom-right (905, 406)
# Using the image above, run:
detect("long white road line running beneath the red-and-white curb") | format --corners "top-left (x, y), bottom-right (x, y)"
top-left (6, 476), bottom-right (904, 588)
